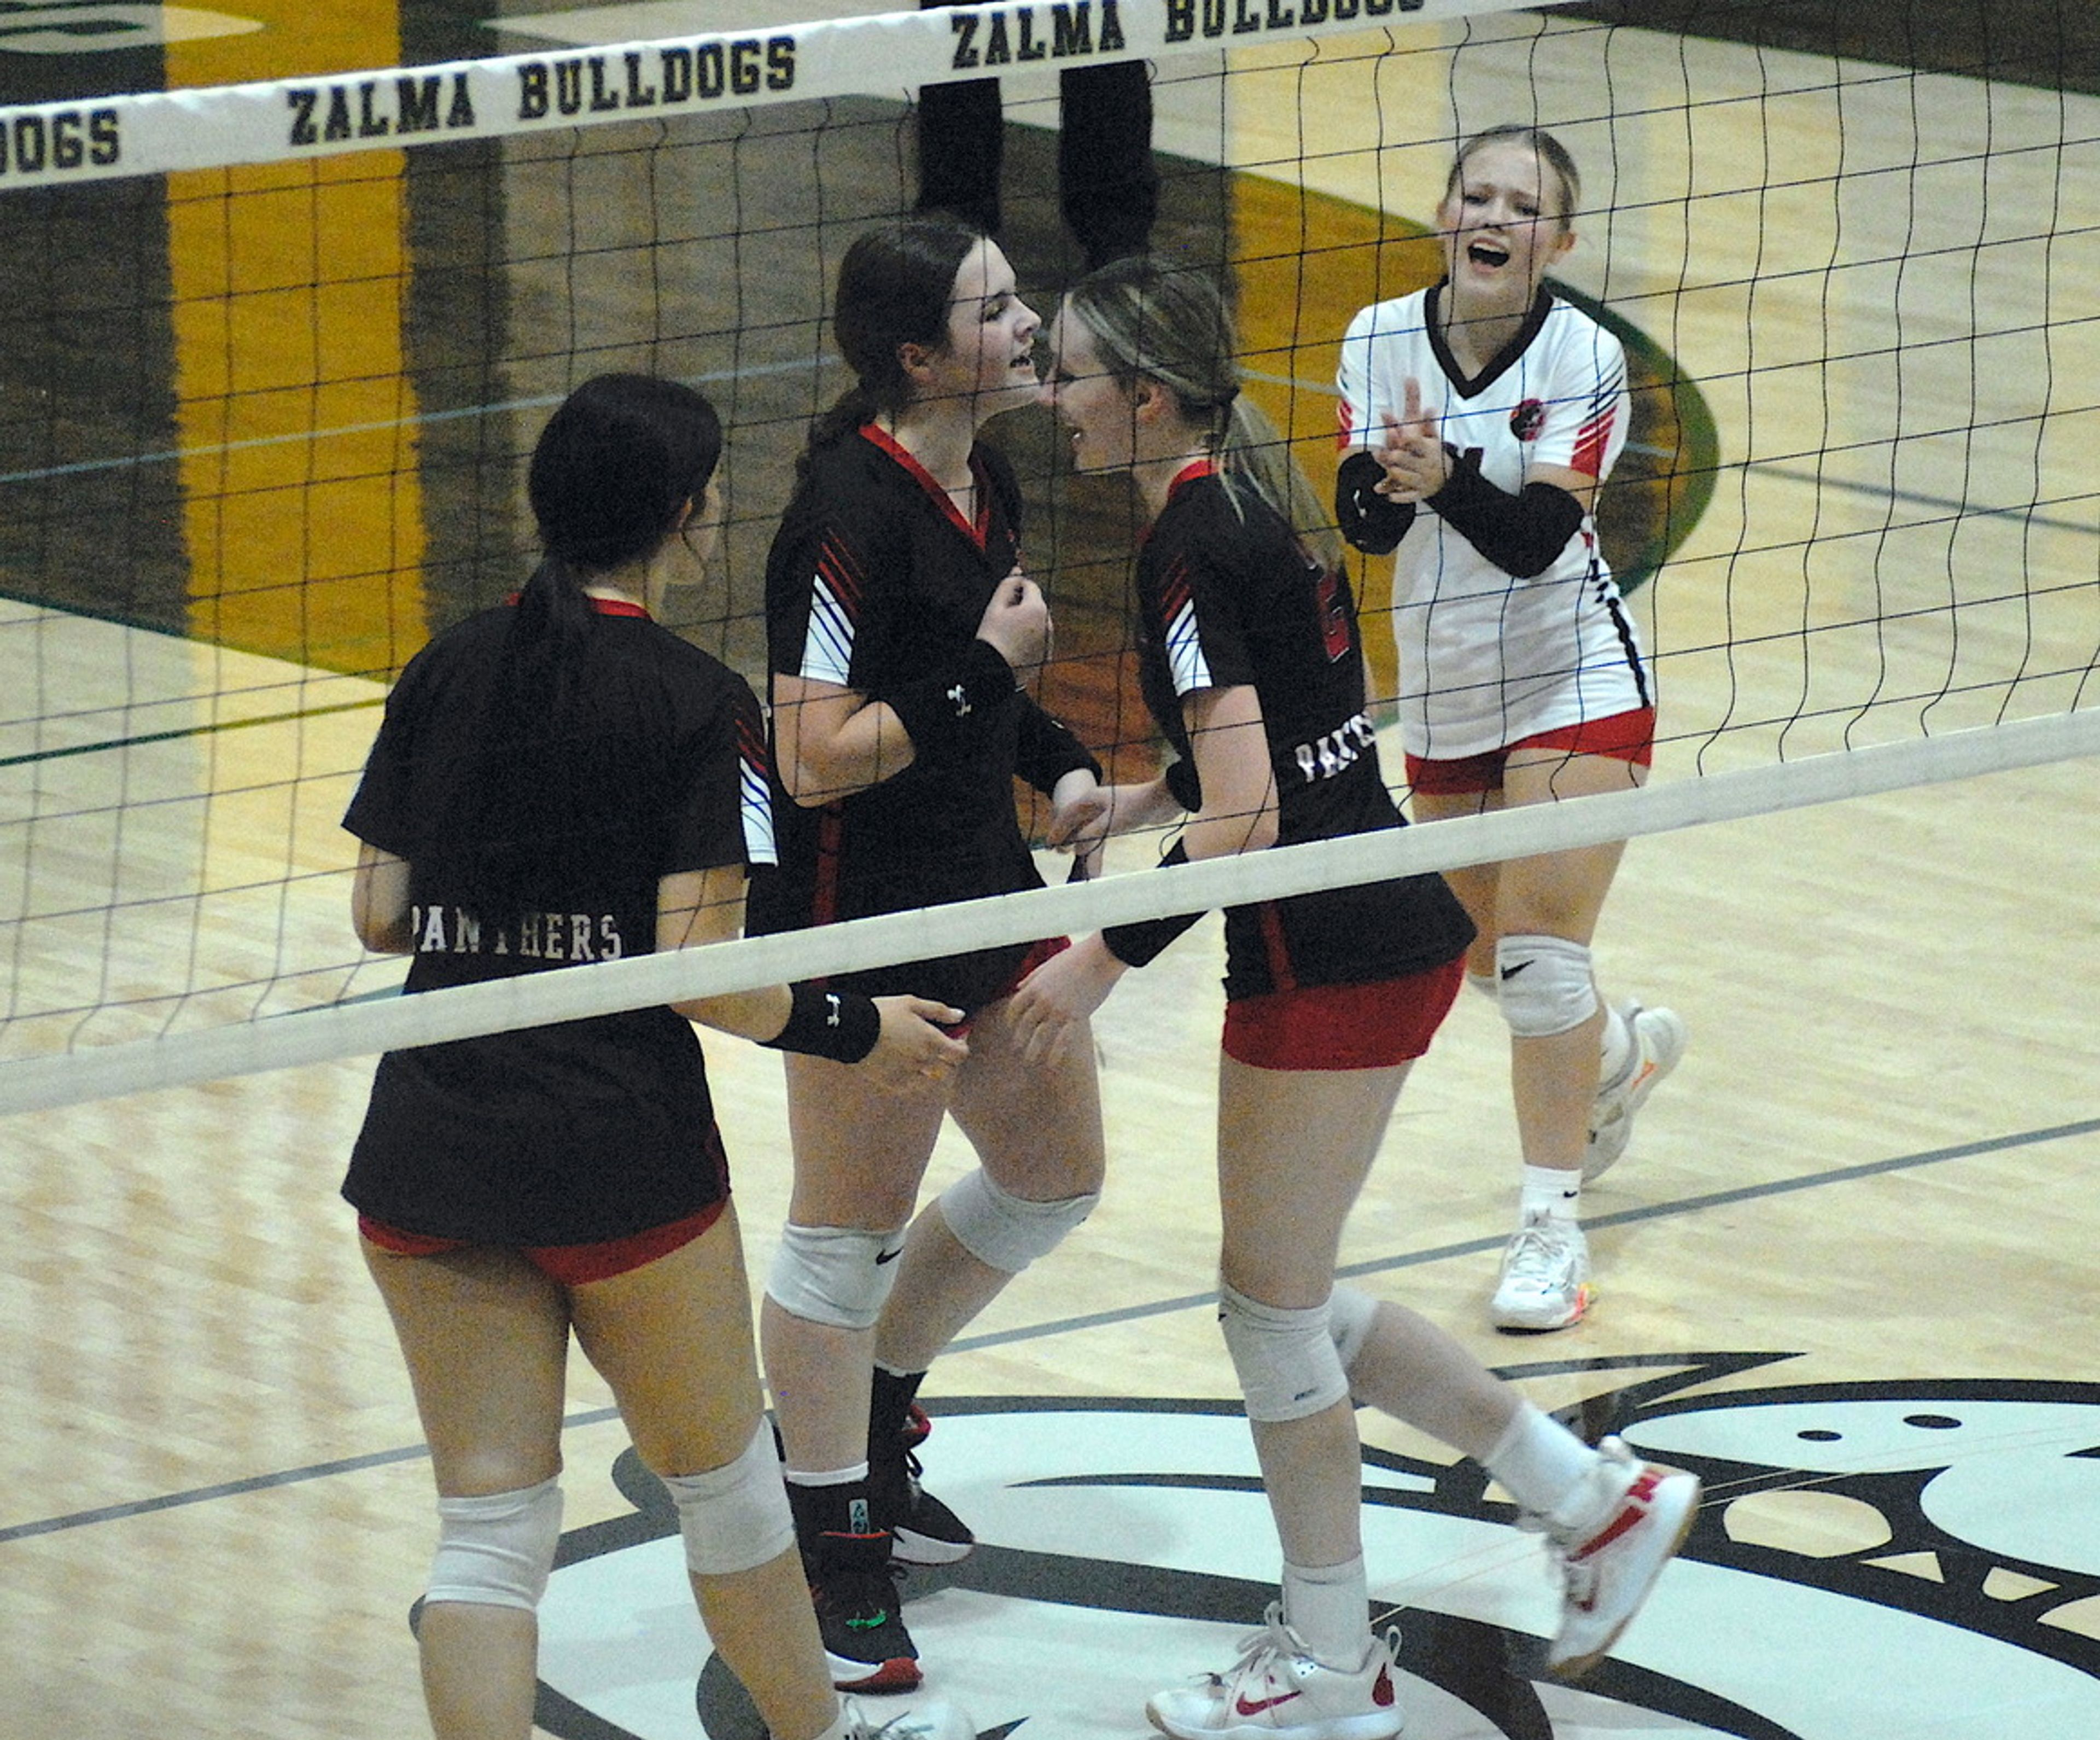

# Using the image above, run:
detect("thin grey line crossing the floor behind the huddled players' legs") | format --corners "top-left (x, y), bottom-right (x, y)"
top-left (0, 1118), bottom-right (2100, 1547)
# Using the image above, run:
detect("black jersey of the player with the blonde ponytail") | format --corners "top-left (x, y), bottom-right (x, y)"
top-left (1138, 462), bottom-right (1472, 998)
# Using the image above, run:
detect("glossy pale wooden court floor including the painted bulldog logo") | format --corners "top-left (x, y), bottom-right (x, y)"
top-left (0, 7), bottom-right (2100, 1740)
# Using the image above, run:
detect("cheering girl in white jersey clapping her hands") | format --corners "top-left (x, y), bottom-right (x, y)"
top-left (1335, 126), bottom-right (1684, 1330)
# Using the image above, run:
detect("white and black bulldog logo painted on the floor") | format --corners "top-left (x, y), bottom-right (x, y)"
top-left (540, 1353), bottom-right (2100, 1740)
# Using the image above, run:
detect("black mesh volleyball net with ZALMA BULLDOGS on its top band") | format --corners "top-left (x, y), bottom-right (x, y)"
top-left (0, 0), bottom-right (2100, 1109)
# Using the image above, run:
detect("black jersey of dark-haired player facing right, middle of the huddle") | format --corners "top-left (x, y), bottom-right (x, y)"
top-left (750, 424), bottom-right (1094, 1009)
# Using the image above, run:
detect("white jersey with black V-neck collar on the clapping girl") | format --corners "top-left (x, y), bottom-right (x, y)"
top-left (1340, 286), bottom-right (1653, 761)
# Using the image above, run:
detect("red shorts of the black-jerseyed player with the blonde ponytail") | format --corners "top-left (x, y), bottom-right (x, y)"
top-left (1224, 954), bottom-right (1466, 1069)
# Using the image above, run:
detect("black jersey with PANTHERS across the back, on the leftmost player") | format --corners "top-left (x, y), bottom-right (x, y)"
top-left (342, 601), bottom-right (773, 1244)
